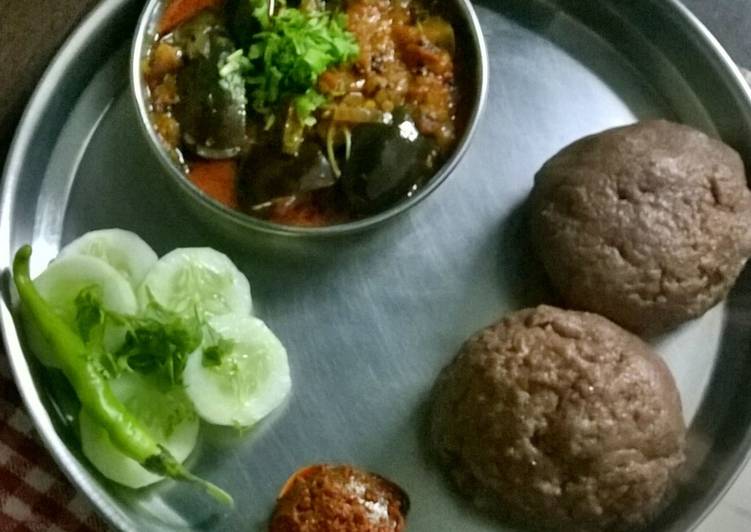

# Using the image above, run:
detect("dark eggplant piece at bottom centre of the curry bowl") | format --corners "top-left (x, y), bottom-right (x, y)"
top-left (238, 142), bottom-right (336, 211)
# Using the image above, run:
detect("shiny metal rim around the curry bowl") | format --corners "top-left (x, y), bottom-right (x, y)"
top-left (129, 0), bottom-right (489, 237)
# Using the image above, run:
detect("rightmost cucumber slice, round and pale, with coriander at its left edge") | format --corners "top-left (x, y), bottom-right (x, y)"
top-left (183, 314), bottom-right (291, 427)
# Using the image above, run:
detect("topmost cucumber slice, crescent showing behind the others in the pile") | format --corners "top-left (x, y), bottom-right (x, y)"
top-left (58, 229), bottom-right (158, 290)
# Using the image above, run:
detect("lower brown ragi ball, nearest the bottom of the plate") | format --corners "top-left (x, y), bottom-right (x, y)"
top-left (431, 306), bottom-right (686, 530)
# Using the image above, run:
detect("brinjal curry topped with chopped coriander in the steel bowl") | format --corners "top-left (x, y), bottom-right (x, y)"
top-left (143, 0), bottom-right (460, 226)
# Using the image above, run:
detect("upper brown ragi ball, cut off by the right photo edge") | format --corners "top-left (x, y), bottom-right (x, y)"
top-left (530, 120), bottom-right (751, 334)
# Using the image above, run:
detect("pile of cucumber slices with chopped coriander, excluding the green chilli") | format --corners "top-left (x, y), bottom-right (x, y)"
top-left (24, 229), bottom-right (291, 488)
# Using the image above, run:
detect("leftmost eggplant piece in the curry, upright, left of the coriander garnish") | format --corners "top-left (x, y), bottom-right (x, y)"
top-left (174, 12), bottom-right (247, 159)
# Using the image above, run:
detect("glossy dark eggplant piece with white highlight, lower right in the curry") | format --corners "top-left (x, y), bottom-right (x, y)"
top-left (341, 112), bottom-right (439, 214)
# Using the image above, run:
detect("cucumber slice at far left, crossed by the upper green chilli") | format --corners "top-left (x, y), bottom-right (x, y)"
top-left (24, 255), bottom-right (138, 367)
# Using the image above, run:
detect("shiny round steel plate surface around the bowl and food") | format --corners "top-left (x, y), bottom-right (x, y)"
top-left (0, 0), bottom-right (751, 532)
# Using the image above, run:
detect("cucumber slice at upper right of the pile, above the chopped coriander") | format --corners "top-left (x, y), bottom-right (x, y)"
top-left (137, 248), bottom-right (252, 318)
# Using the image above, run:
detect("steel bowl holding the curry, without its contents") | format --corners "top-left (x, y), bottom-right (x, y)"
top-left (130, 0), bottom-right (488, 238)
